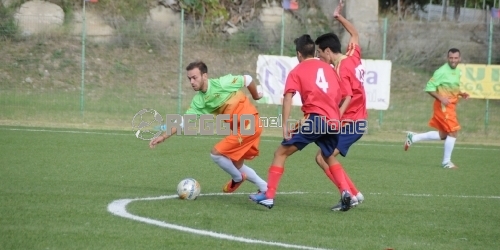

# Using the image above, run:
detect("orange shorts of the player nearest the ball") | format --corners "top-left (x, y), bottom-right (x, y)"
top-left (215, 115), bottom-right (262, 161)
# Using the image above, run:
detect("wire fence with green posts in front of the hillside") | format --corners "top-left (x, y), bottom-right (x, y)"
top-left (0, 2), bottom-right (500, 143)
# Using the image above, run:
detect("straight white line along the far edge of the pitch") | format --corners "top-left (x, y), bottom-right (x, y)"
top-left (0, 128), bottom-right (500, 151)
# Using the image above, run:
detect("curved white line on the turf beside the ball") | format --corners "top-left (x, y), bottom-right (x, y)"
top-left (108, 192), bottom-right (336, 250)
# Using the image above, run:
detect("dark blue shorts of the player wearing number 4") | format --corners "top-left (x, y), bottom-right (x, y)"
top-left (281, 114), bottom-right (340, 157)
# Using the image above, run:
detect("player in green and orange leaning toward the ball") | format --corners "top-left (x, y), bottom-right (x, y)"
top-left (149, 61), bottom-right (267, 193)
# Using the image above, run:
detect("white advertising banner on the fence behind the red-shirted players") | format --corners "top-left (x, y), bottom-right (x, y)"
top-left (257, 55), bottom-right (392, 110)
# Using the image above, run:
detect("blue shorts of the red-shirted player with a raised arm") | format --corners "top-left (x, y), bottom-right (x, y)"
top-left (337, 121), bottom-right (368, 157)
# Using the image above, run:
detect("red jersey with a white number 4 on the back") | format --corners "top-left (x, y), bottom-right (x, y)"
top-left (284, 59), bottom-right (345, 120)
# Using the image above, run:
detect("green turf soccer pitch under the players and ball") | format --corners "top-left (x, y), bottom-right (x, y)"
top-left (0, 126), bottom-right (500, 250)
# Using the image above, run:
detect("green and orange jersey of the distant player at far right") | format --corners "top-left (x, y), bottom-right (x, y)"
top-left (425, 63), bottom-right (462, 103)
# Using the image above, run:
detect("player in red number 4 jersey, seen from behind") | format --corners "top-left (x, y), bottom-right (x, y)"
top-left (250, 35), bottom-right (351, 211)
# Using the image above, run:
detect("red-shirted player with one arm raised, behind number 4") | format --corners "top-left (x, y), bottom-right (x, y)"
top-left (315, 0), bottom-right (368, 211)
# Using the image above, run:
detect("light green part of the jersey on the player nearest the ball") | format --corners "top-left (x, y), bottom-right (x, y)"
top-left (186, 74), bottom-right (245, 116)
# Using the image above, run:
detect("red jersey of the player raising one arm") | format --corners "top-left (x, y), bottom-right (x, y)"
top-left (335, 43), bottom-right (368, 121)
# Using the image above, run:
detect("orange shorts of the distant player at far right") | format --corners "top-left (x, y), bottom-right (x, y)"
top-left (429, 102), bottom-right (460, 133)
